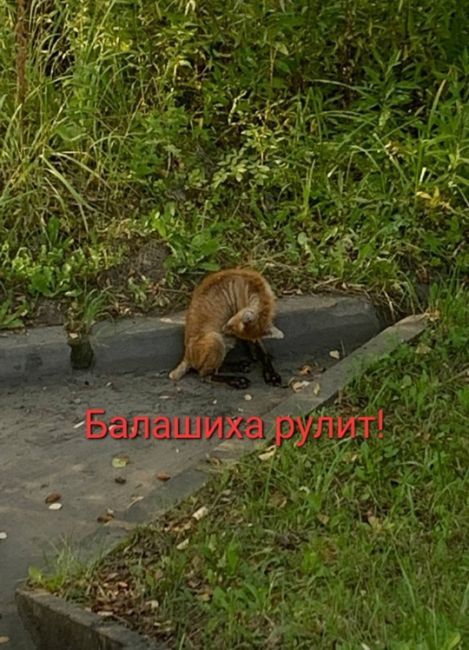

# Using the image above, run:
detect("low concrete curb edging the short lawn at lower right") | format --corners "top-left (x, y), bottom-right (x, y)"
top-left (16, 315), bottom-right (427, 650)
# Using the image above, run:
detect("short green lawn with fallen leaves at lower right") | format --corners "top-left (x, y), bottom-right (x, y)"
top-left (36, 285), bottom-right (469, 650)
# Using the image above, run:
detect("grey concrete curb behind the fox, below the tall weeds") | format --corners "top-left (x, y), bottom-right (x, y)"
top-left (0, 294), bottom-right (381, 385)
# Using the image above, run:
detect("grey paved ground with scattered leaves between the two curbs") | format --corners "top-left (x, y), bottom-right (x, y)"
top-left (0, 352), bottom-right (334, 650)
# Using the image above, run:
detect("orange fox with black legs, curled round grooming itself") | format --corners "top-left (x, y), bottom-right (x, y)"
top-left (169, 269), bottom-right (284, 388)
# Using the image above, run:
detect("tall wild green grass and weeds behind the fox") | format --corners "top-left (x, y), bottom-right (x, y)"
top-left (0, 0), bottom-right (469, 327)
